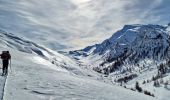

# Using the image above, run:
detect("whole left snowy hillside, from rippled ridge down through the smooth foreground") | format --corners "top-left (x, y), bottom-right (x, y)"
top-left (0, 31), bottom-right (156, 100)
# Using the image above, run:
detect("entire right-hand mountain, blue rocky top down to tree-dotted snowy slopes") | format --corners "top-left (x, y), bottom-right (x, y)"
top-left (69, 25), bottom-right (170, 100)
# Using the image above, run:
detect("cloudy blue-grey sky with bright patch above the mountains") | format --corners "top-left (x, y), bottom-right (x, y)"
top-left (0, 0), bottom-right (170, 50)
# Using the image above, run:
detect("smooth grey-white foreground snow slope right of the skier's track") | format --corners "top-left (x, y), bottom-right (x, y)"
top-left (4, 52), bottom-right (155, 100)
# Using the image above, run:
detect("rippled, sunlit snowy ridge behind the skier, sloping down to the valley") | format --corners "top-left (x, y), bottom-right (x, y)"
top-left (0, 31), bottom-right (87, 73)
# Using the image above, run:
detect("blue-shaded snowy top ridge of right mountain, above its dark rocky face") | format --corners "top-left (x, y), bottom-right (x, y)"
top-left (72, 24), bottom-right (167, 56)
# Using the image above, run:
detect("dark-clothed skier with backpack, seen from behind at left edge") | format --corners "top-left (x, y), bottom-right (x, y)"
top-left (0, 51), bottom-right (11, 76)
